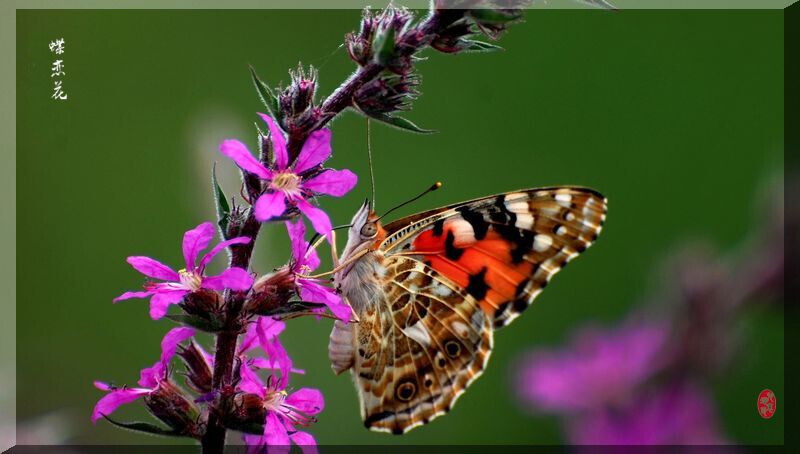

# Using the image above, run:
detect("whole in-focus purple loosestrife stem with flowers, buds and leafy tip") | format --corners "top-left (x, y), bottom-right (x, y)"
top-left (92, 0), bottom-right (536, 453)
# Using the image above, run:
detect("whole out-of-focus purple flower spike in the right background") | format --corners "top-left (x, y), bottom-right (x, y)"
top-left (517, 180), bottom-right (784, 445)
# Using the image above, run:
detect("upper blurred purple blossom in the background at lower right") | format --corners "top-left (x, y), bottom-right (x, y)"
top-left (519, 322), bottom-right (667, 413)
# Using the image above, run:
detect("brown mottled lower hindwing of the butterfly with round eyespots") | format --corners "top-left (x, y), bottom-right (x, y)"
top-left (354, 256), bottom-right (492, 434)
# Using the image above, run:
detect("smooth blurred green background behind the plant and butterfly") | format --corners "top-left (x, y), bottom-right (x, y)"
top-left (17, 10), bottom-right (784, 444)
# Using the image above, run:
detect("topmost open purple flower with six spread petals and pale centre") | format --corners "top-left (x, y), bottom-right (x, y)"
top-left (220, 113), bottom-right (357, 238)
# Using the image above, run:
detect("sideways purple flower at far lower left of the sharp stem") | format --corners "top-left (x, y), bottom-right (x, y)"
top-left (92, 328), bottom-right (195, 423)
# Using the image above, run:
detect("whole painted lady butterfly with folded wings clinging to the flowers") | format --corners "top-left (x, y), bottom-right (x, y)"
top-left (328, 186), bottom-right (606, 434)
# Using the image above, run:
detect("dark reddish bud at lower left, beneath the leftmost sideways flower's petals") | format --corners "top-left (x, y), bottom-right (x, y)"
top-left (144, 380), bottom-right (203, 438)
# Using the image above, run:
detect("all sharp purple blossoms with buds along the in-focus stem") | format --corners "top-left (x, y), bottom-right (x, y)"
top-left (92, 112), bottom-right (357, 446)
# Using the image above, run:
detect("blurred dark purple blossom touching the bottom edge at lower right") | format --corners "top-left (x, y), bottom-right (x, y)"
top-left (567, 383), bottom-right (726, 445)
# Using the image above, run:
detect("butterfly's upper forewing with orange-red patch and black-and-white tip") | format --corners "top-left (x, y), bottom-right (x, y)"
top-left (381, 187), bottom-right (606, 327)
